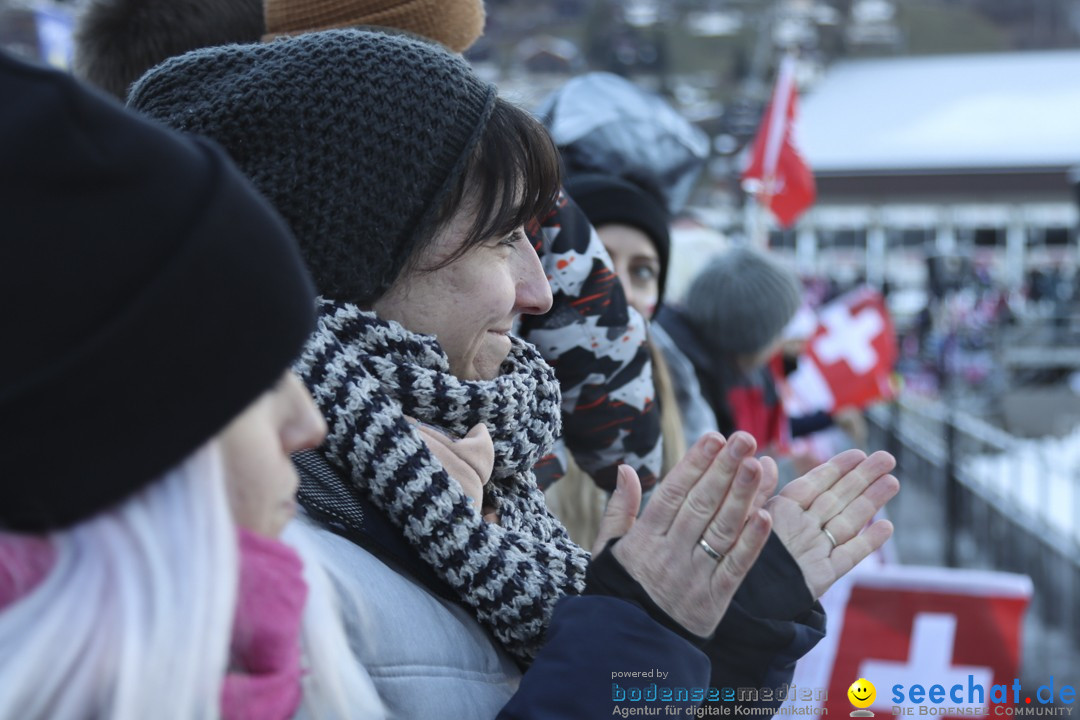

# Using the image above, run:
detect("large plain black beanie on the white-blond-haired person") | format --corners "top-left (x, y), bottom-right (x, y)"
top-left (0, 53), bottom-right (314, 532)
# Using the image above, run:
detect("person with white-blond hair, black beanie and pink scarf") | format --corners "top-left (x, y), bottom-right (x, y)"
top-left (0, 47), bottom-right (381, 720)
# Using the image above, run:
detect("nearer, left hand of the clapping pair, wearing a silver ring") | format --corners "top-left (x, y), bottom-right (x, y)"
top-left (602, 433), bottom-right (772, 637)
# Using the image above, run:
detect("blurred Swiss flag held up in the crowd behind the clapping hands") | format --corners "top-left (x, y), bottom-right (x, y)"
top-left (785, 287), bottom-right (896, 415)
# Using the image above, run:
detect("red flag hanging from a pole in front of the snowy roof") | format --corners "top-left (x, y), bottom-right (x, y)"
top-left (742, 55), bottom-right (818, 228)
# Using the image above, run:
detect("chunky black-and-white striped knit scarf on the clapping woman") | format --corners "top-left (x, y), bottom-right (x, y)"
top-left (296, 300), bottom-right (589, 662)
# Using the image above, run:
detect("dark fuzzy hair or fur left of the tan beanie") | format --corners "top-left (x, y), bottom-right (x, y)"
top-left (73, 0), bottom-right (266, 100)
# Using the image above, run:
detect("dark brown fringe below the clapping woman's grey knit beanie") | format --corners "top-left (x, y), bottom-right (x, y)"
top-left (413, 98), bottom-right (562, 270)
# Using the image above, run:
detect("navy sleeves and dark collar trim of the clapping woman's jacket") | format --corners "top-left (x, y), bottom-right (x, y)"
top-left (294, 452), bottom-right (824, 720)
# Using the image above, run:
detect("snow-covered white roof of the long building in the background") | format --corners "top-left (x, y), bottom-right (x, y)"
top-left (796, 51), bottom-right (1080, 172)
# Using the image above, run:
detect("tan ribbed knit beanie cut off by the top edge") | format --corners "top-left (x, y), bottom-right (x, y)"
top-left (262, 0), bottom-right (484, 53)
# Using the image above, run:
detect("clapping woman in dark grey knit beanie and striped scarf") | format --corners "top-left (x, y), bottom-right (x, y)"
top-left (130, 30), bottom-right (896, 717)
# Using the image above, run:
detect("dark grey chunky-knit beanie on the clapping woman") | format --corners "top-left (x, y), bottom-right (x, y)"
top-left (127, 30), bottom-right (496, 307)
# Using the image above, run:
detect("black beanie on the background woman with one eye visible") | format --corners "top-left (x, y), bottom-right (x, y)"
top-left (566, 174), bottom-right (672, 308)
